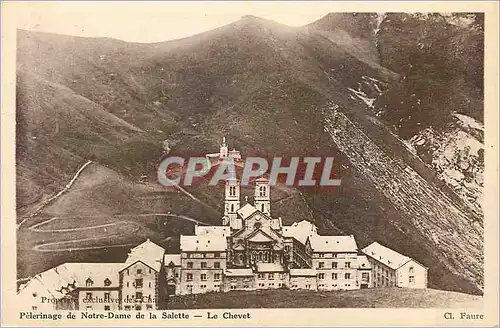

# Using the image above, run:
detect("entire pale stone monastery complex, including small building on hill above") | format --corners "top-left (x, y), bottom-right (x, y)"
top-left (19, 140), bottom-right (427, 310)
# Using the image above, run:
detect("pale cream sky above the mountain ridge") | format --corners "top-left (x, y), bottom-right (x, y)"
top-left (8, 1), bottom-right (352, 42)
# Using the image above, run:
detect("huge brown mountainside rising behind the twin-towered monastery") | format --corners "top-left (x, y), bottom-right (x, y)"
top-left (16, 13), bottom-right (483, 293)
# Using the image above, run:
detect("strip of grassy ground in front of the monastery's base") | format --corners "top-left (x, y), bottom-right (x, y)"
top-left (169, 288), bottom-right (483, 309)
